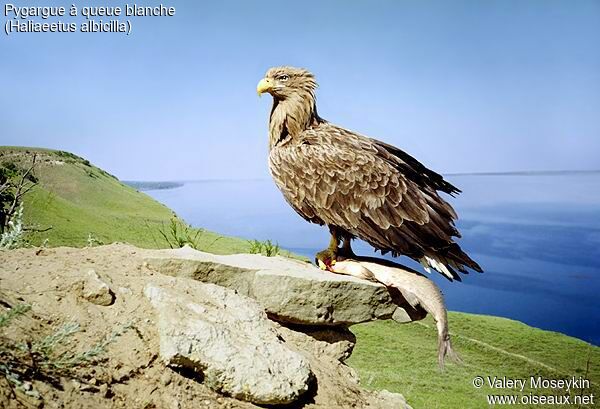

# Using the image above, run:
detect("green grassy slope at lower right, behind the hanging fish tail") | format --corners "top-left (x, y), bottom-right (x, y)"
top-left (347, 312), bottom-right (600, 409)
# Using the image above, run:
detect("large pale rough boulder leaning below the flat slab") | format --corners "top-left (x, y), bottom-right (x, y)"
top-left (144, 279), bottom-right (313, 404)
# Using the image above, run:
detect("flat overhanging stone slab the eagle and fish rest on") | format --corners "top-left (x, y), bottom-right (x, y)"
top-left (144, 247), bottom-right (410, 326)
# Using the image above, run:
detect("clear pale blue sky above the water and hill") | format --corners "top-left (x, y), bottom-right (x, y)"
top-left (0, 0), bottom-right (600, 180)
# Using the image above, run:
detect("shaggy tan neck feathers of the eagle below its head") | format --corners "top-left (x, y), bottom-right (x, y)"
top-left (269, 92), bottom-right (322, 149)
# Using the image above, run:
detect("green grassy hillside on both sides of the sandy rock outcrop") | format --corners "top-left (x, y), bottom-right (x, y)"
top-left (0, 147), bottom-right (600, 409)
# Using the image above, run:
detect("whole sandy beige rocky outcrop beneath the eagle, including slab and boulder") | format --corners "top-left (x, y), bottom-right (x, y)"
top-left (0, 244), bottom-right (409, 409)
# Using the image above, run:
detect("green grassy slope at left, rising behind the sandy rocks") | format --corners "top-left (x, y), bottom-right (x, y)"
top-left (0, 146), bottom-right (249, 253)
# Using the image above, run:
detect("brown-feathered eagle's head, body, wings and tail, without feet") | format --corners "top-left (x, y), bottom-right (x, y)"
top-left (257, 67), bottom-right (481, 280)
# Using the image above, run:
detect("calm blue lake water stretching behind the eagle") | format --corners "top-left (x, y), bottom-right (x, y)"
top-left (147, 173), bottom-right (600, 345)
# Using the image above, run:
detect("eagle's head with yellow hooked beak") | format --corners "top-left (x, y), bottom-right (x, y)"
top-left (256, 67), bottom-right (317, 99)
